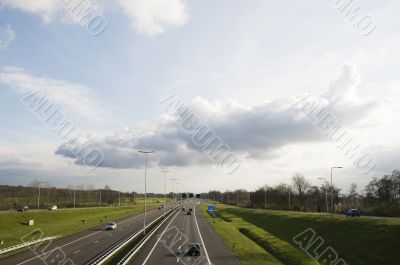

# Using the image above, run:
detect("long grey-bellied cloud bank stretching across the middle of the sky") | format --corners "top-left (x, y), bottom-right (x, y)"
top-left (57, 67), bottom-right (381, 168)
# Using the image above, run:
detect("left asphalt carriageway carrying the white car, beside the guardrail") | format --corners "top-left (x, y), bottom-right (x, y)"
top-left (0, 205), bottom-right (172, 265)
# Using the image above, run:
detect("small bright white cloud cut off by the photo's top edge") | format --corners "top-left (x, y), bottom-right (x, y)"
top-left (118, 0), bottom-right (187, 36)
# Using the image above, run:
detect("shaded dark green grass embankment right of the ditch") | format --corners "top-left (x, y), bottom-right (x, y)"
top-left (217, 205), bottom-right (400, 265)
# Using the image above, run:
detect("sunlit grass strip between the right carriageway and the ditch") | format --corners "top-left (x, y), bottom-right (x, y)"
top-left (201, 204), bottom-right (282, 265)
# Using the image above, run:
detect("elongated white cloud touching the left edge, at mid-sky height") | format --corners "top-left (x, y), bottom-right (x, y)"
top-left (0, 67), bottom-right (105, 120)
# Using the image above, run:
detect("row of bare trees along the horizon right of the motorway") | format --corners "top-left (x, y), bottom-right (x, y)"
top-left (206, 170), bottom-right (400, 216)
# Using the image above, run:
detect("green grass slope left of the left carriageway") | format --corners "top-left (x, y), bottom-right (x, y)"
top-left (0, 200), bottom-right (158, 253)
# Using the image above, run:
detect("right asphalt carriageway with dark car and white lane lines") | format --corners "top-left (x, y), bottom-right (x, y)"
top-left (131, 201), bottom-right (240, 265)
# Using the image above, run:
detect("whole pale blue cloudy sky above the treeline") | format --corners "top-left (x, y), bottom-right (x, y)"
top-left (0, 0), bottom-right (400, 192)
